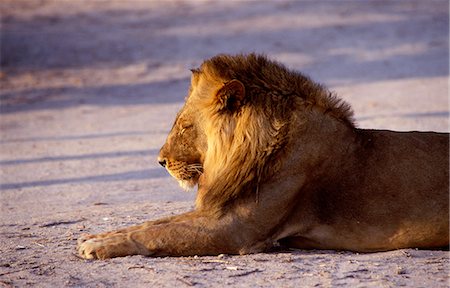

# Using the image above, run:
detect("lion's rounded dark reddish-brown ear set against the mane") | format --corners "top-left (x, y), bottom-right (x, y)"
top-left (217, 79), bottom-right (245, 112)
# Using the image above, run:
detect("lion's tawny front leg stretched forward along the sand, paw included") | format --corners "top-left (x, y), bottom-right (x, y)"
top-left (78, 213), bottom-right (267, 259)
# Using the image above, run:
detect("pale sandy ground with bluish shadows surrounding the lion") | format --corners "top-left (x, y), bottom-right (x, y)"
top-left (0, 0), bottom-right (449, 287)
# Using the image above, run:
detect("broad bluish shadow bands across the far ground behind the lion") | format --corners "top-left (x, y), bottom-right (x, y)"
top-left (1, 1), bottom-right (449, 113)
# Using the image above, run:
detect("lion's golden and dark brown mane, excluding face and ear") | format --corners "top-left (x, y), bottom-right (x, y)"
top-left (194, 54), bottom-right (354, 212)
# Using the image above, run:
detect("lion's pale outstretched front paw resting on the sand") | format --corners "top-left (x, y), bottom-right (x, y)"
top-left (78, 233), bottom-right (150, 259)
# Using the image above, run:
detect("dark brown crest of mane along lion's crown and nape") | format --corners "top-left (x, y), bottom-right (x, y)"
top-left (201, 53), bottom-right (354, 126)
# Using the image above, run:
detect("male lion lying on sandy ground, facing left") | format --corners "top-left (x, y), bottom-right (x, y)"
top-left (78, 54), bottom-right (449, 259)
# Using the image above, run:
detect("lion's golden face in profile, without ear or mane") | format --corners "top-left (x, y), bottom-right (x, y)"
top-left (158, 72), bottom-right (207, 189)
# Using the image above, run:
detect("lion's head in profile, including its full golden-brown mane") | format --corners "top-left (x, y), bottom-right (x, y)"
top-left (158, 54), bottom-right (352, 209)
